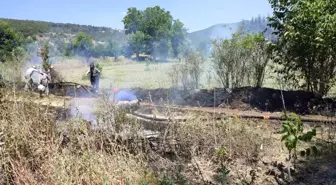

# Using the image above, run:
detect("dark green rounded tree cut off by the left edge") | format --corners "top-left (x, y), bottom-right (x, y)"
top-left (0, 21), bottom-right (21, 62)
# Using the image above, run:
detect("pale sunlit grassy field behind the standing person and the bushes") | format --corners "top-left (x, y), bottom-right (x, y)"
top-left (55, 59), bottom-right (286, 89)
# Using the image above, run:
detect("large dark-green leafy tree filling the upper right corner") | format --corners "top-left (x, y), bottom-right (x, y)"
top-left (269, 0), bottom-right (336, 95)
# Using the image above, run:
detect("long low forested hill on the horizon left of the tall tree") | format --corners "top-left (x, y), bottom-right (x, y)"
top-left (0, 18), bottom-right (125, 41)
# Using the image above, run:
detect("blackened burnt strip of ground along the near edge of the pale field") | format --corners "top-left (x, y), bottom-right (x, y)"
top-left (2, 83), bottom-right (336, 115)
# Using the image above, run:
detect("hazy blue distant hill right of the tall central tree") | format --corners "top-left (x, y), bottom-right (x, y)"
top-left (188, 16), bottom-right (272, 49)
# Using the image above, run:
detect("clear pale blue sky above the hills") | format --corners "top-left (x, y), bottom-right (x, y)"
top-left (0, 0), bottom-right (272, 31)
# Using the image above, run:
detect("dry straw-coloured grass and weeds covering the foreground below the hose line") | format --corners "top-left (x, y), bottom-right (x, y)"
top-left (0, 86), bottom-right (332, 185)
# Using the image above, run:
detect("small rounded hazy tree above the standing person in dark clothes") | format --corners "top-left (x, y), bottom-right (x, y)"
top-left (72, 32), bottom-right (93, 58)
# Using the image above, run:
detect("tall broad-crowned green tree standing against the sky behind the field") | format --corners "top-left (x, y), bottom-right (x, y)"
top-left (123, 6), bottom-right (187, 60)
